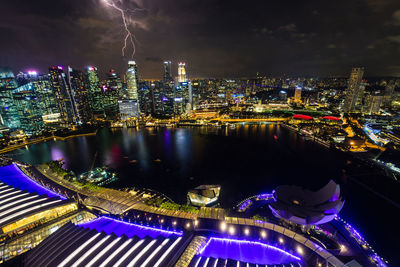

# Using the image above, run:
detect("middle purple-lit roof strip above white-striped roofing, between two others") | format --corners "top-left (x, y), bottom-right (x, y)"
top-left (79, 217), bottom-right (182, 238)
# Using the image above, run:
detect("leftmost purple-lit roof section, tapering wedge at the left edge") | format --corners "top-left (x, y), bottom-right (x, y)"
top-left (0, 164), bottom-right (66, 199)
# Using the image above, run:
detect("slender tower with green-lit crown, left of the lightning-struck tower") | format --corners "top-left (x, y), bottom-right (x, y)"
top-left (86, 66), bottom-right (104, 116)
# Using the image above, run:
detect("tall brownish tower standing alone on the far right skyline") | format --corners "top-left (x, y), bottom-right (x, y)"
top-left (343, 68), bottom-right (365, 113)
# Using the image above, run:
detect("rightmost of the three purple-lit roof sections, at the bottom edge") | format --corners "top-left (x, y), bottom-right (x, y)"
top-left (200, 237), bottom-right (301, 264)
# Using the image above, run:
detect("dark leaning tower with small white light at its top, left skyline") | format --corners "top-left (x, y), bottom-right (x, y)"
top-left (49, 66), bottom-right (76, 125)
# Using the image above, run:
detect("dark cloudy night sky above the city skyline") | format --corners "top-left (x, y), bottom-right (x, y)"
top-left (0, 0), bottom-right (400, 78)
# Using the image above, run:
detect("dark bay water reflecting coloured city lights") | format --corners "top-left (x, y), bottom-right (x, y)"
top-left (9, 124), bottom-right (400, 266)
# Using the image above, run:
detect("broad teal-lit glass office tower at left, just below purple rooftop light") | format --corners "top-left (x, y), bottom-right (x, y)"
top-left (13, 82), bottom-right (44, 136)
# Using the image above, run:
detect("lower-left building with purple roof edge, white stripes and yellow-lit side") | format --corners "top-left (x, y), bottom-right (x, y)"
top-left (0, 164), bottom-right (95, 266)
